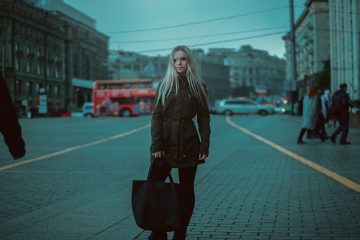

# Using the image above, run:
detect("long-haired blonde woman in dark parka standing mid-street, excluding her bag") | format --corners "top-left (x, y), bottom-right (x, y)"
top-left (149, 46), bottom-right (210, 240)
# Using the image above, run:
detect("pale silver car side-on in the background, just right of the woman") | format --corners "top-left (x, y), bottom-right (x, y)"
top-left (212, 98), bottom-right (275, 116)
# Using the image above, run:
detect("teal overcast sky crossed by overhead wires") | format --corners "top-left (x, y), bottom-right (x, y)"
top-left (64, 0), bottom-right (305, 57)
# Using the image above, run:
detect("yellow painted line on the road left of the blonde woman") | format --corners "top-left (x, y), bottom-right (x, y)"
top-left (0, 124), bottom-right (150, 171)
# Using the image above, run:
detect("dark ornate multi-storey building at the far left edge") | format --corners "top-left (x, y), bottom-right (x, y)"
top-left (0, 0), bottom-right (66, 113)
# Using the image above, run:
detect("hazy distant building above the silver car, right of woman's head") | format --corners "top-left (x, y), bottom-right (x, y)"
top-left (209, 45), bottom-right (285, 96)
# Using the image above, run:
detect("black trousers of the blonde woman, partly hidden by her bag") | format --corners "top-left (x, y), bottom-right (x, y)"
top-left (149, 164), bottom-right (197, 231)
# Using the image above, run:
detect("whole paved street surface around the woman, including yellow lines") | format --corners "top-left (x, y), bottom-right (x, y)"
top-left (0, 115), bottom-right (360, 240)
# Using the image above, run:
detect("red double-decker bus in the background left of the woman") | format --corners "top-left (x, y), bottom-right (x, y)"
top-left (93, 79), bottom-right (160, 117)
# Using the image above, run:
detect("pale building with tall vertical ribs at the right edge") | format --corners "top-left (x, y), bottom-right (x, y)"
top-left (329, 0), bottom-right (360, 100)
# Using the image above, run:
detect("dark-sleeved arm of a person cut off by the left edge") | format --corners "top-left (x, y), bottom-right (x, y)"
top-left (0, 73), bottom-right (26, 159)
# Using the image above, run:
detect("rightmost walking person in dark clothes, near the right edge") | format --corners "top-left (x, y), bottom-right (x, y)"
top-left (330, 83), bottom-right (352, 145)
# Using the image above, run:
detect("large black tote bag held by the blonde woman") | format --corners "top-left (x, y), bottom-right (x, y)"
top-left (131, 165), bottom-right (180, 232)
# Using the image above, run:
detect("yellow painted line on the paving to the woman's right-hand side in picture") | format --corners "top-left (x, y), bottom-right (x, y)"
top-left (226, 117), bottom-right (360, 192)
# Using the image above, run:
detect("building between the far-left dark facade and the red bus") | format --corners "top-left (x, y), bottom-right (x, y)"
top-left (31, 0), bottom-right (109, 107)
